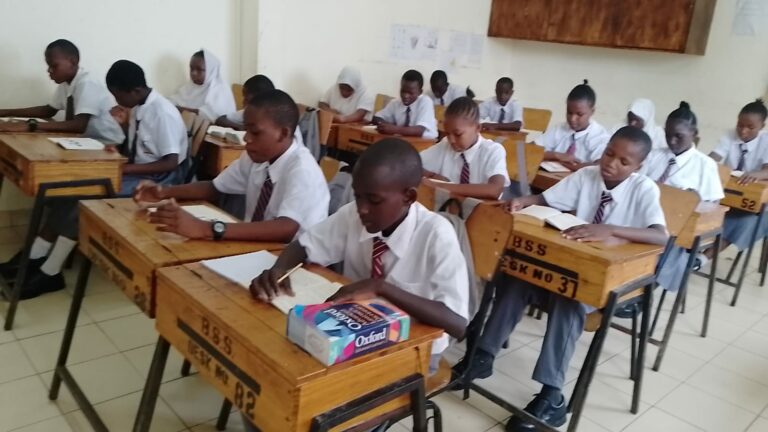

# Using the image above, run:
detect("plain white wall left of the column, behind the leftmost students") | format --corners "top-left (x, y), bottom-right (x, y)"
top-left (0, 0), bottom-right (242, 210)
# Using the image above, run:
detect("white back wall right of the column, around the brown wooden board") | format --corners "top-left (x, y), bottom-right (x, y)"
top-left (250, 0), bottom-right (768, 150)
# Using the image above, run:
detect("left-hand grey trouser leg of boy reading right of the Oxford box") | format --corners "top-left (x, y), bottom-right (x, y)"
top-left (455, 277), bottom-right (540, 380)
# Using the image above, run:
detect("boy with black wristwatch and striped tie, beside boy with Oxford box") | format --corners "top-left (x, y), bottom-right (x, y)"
top-left (134, 90), bottom-right (330, 243)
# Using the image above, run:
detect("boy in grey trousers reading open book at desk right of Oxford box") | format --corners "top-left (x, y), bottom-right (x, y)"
top-left (455, 126), bottom-right (668, 432)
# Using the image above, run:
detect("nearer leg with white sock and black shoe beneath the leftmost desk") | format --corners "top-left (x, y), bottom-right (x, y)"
top-left (21, 199), bottom-right (78, 299)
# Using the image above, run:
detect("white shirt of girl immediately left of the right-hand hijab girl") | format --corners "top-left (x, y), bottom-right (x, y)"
top-left (534, 120), bottom-right (611, 162)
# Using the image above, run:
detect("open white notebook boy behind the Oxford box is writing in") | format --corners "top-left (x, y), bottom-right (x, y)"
top-left (201, 251), bottom-right (341, 314)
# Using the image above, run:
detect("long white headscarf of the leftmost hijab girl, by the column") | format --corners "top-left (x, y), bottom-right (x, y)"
top-left (169, 49), bottom-right (237, 121)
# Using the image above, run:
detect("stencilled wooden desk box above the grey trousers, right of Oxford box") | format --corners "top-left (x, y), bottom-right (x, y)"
top-left (501, 219), bottom-right (662, 309)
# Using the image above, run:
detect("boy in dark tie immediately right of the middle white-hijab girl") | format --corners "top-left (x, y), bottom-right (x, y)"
top-left (373, 69), bottom-right (437, 139)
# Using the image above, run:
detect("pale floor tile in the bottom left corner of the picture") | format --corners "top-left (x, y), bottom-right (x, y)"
top-left (0, 376), bottom-right (61, 431)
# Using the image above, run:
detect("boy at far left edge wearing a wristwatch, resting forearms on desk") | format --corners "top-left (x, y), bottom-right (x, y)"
top-left (0, 39), bottom-right (125, 144)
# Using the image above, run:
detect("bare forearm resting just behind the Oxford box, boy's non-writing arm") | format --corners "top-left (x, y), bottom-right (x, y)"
top-left (328, 279), bottom-right (467, 339)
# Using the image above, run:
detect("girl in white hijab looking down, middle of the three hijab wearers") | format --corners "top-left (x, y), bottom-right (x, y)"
top-left (320, 66), bottom-right (373, 123)
